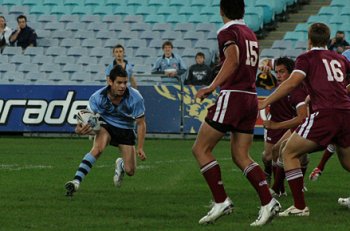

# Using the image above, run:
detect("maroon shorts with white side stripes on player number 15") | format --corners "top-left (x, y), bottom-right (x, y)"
top-left (205, 90), bottom-right (258, 134)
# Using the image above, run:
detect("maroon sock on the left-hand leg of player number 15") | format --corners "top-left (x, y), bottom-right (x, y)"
top-left (201, 160), bottom-right (227, 203)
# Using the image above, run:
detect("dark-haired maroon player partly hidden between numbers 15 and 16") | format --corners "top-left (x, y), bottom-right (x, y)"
top-left (259, 57), bottom-right (308, 196)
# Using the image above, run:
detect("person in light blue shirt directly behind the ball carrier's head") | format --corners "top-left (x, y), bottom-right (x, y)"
top-left (105, 44), bottom-right (137, 88)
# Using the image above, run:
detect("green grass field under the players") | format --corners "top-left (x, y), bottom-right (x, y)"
top-left (0, 137), bottom-right (350, 231)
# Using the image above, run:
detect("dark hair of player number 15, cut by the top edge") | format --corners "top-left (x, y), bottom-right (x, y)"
top-left (220, 0), bottom-right (244, 20)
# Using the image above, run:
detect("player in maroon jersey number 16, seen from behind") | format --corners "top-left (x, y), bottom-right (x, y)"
top-left (259, 23), bottom-right (350, 216)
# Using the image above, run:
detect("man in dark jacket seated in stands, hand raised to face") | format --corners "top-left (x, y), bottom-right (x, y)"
top-left (10, 15), bottom-right (37, 50)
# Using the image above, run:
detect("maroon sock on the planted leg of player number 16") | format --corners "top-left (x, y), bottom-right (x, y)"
top-left (286, 168), bottom-right (306, 209)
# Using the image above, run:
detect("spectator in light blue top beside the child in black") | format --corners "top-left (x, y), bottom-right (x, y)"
top-left (152, 41), bottom-right (187, 77)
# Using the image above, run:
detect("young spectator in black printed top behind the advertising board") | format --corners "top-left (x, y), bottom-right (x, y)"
top-left (184, 52), bottom-right (213, 85)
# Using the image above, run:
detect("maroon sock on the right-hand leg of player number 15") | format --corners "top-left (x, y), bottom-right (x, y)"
top-left (243, 162), bottom-right (272, 206)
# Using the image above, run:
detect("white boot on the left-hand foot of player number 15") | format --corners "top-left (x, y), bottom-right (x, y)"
top-left (199, 197), bottom-right (233, 224)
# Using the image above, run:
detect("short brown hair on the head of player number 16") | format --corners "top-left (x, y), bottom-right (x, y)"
top-left (308, 22), bottom-right (331, 47)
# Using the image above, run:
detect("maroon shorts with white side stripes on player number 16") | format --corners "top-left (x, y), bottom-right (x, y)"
top-left (296, 109), bottom-right (350, 148)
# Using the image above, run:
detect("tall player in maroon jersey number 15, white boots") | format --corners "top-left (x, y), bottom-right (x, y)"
top-left (192, 0), bottom-right (280, 226)
